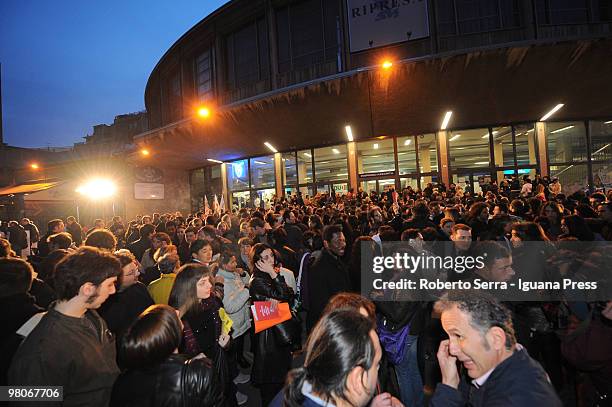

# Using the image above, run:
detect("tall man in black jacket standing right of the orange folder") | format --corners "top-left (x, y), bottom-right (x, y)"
top-left (306, 225), bottom-right (351, 331)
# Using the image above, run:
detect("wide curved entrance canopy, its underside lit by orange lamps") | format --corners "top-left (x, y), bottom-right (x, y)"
top-left (132, 40), bottom-right (612, 170)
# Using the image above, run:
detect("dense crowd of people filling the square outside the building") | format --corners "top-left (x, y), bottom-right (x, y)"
top-left (0, 177), bottom-right (612, 407)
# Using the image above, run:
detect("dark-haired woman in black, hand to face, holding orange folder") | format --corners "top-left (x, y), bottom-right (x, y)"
top-left (249, 243), bottom-right (294, 406)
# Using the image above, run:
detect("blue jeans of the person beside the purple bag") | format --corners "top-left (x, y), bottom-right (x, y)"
top-left (395, 335), bottom-right (424, 407)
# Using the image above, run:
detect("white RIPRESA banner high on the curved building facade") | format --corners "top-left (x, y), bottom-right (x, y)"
top-left (346, 0), bottom-right (429, 52)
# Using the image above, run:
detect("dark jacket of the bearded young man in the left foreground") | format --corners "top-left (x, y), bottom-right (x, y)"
top-left (8, 308), bottom-right (119, 407)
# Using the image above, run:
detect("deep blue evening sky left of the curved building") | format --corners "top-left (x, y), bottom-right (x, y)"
top-left (0, 0), bottom-right (227, 147)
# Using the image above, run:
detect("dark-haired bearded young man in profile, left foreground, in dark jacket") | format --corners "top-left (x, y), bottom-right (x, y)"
top-left (8, 247), bottom-right (121, 406)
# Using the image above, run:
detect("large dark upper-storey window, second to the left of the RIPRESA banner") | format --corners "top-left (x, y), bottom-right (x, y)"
top-left (226, 19), bottom-right (270, 89)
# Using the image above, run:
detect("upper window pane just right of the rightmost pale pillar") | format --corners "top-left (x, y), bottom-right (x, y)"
top-left (546, 122), bottom-right (587, 164)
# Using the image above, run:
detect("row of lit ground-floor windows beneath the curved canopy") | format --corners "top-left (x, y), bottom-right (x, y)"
top-left (192, 121), bottom-right (612, 210)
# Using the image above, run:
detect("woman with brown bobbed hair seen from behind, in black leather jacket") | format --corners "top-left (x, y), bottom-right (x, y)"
top-left (110, 304), bottom-right (223, 407)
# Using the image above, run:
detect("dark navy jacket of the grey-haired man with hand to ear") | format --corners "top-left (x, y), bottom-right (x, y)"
top-left (429, 349), bottom-right (561, 407)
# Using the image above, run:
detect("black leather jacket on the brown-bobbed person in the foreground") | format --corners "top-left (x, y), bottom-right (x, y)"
top-left (110, 354), bottom-right (224, 407)
